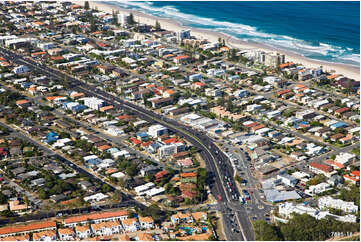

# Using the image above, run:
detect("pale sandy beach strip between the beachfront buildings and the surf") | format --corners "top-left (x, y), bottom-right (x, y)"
top-left (73, 1), bottom-right (360, 81)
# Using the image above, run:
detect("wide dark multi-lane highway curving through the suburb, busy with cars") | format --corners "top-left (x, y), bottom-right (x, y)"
top-left (0, 48), bottom-right (254, 240)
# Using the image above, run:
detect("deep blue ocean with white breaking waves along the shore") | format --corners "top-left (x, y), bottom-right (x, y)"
top-left (111, 1), bottom-right (360, 66)
